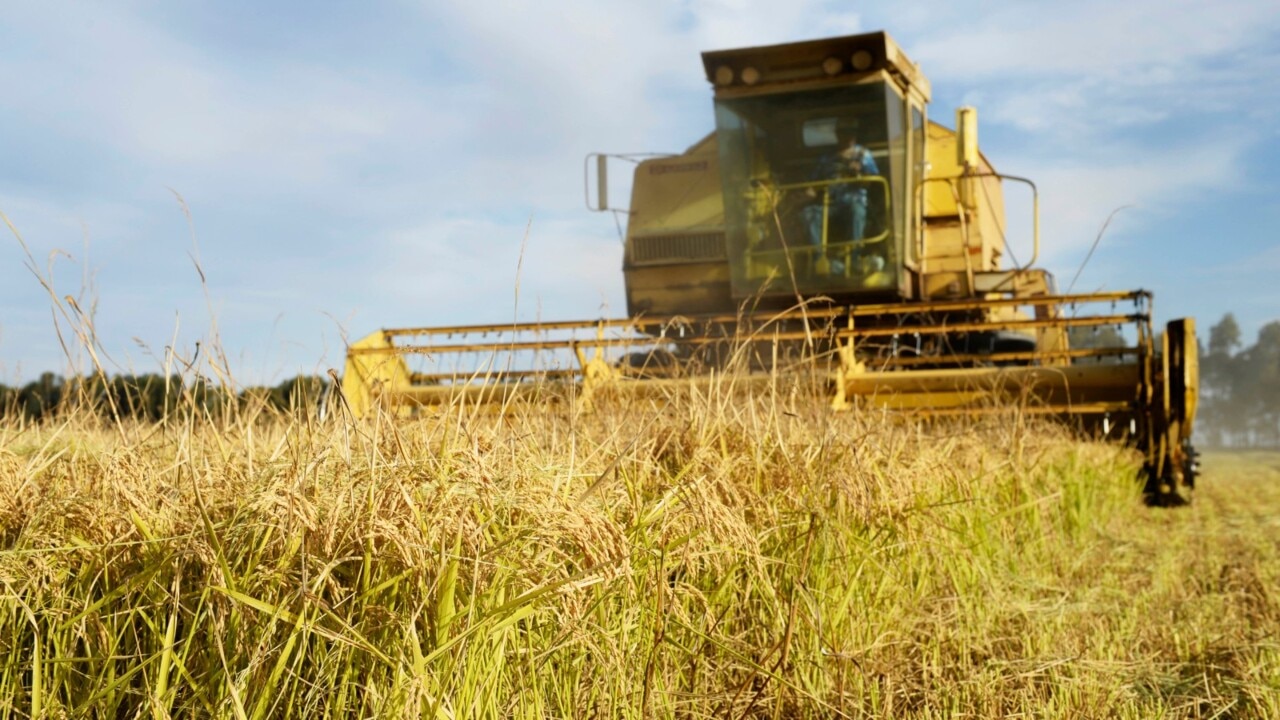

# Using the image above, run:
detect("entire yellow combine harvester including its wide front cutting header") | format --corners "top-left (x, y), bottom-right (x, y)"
top-left (342, 32), bottom-right (1198, 503)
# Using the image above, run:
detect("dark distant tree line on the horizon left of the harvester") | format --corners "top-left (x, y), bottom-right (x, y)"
top-left (0, 373), bottom-right (330, 421)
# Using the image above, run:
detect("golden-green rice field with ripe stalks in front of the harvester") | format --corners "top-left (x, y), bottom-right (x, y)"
top-left (0, 393), bottom-right (1280, 719)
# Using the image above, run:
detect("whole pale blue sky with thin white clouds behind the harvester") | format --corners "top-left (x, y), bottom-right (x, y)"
top-left (0, 0), bottom-right (1280, 386)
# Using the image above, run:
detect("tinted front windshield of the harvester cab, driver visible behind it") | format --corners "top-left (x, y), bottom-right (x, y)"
top-left (716, 82), bottom-right (906, 297)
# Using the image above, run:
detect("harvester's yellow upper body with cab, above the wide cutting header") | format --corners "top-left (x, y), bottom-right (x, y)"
top-left (623, 32), bottom-right (1029, 316)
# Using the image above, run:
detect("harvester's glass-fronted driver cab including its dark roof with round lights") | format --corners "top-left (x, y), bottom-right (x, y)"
top-left (703, 33), bottom-right (928, 304)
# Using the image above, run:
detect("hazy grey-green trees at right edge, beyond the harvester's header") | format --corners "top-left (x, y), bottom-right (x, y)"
top-left (1196, 313), bottom-right (1280, 447)
